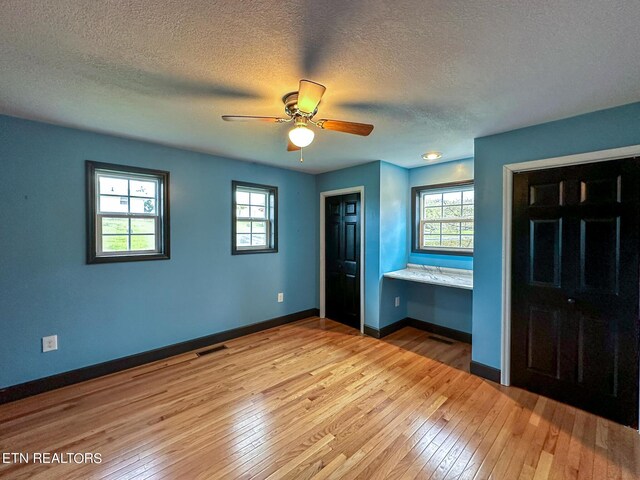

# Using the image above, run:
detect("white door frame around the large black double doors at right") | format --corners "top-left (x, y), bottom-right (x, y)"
top-left (500, 145), bottom-right (640, 426)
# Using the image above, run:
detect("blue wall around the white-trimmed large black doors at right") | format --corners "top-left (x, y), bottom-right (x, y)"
top-left (472, 103), bottom-right (640, 368)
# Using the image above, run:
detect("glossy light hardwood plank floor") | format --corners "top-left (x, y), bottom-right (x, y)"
top-left (0, 318), bottom-right (640, 480)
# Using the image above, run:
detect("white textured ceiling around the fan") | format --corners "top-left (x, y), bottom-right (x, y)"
top-left (0, 0), bottom-right (640, 172)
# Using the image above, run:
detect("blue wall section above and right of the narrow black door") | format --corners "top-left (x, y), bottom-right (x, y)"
top-left (316, 162), bottom-right (380, 328)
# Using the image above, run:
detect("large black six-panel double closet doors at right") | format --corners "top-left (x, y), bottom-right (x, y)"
top-left (511, 159), bottom-right (640, 427)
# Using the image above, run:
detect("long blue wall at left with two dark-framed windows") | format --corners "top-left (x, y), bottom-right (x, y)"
top-left (0, 116), bottom-right (318, 387)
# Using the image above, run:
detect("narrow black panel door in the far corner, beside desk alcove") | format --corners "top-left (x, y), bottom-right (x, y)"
top-left (325, 193), bottom-right (360, 329)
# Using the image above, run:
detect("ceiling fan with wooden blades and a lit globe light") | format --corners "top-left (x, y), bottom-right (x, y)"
top-left (222, 80), bottom-right (373, 152)
